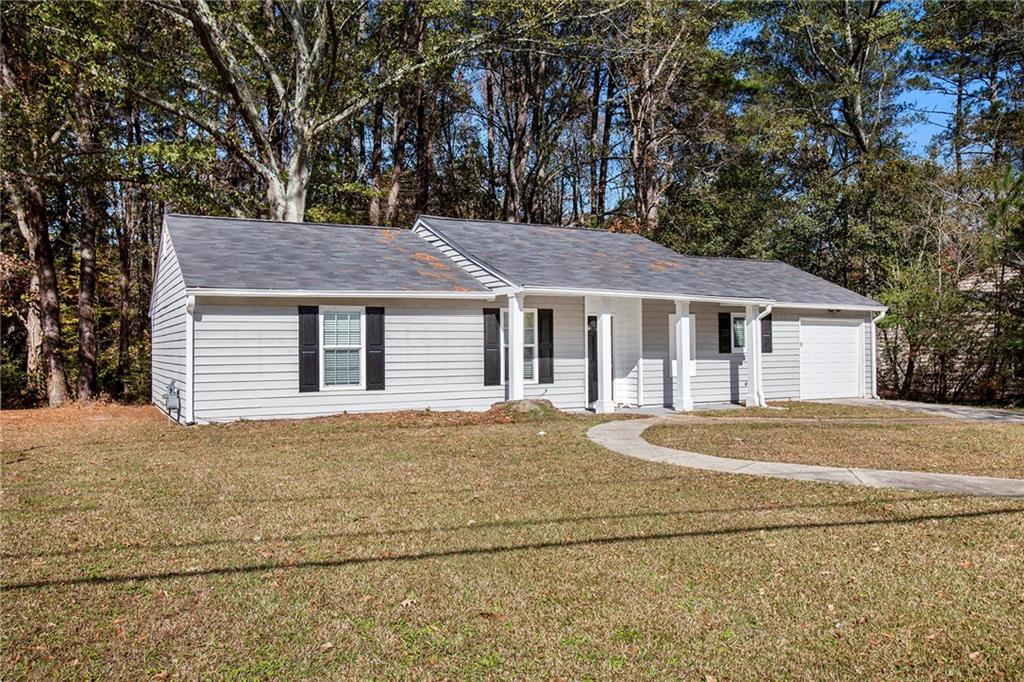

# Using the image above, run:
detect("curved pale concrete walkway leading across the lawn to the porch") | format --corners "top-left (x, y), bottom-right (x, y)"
top-left (587, 417), bottom-right (1024, 498)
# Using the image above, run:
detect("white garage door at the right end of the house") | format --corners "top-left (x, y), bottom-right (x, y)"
top-left (800, 317), bottom-right (863, 399)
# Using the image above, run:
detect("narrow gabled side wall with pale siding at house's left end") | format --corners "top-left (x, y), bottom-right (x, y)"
top-left (150, 229), bottom-right (188, 420)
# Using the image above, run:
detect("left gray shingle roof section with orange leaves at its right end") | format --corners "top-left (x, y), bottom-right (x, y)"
top-left (165, 215), bottom-right (487, 292)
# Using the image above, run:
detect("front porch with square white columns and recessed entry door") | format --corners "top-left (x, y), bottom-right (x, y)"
top-left (503, 292), bottom-right (778, 413)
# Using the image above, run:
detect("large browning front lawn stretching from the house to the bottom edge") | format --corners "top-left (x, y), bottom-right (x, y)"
top-left (0, 408), bottom-right (1024, 680)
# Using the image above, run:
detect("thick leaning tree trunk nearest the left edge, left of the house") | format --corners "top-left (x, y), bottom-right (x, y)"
top-left (9, 175), bottom-right (68, 408)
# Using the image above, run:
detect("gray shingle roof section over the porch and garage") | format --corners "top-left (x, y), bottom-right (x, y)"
top-left (420, 216), bottom-right (883, 308)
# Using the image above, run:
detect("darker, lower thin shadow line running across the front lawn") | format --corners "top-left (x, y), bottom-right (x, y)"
top-left (0, 496), bottom-right (1024, 592)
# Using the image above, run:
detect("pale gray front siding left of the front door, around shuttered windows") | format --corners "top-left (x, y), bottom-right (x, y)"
top-left (195, 297), bottom-right (586, 422)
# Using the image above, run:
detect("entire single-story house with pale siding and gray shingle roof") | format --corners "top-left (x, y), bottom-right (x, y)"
top-left (151, 215), bottom-right (885, 423)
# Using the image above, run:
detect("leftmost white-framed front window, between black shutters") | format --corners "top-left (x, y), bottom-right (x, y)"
top-left (321, 307), bottom-right (367, 388)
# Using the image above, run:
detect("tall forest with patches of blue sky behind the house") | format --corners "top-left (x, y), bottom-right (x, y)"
top-left (0, 0), bottom-right (1024, 408)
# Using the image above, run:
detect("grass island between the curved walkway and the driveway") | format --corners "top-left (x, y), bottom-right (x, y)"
top-left (644, 402), bottom-right (1024, 478)
